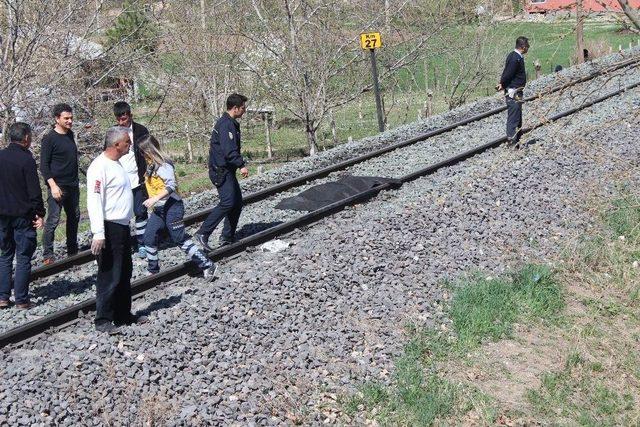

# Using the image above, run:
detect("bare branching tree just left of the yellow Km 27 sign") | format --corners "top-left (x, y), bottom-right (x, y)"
top-left (238, 0), bottom-right (439, 155)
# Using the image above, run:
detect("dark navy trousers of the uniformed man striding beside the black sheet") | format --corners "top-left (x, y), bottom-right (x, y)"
top-left (198, 173), bottom-right (242, 240)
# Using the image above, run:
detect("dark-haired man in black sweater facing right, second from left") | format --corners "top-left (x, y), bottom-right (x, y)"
top-left (40, 104), bottom-right (80, 264)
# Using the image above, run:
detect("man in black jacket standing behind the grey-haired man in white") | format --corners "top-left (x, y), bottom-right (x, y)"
top-left (113, 101), bottom-right (149, 258)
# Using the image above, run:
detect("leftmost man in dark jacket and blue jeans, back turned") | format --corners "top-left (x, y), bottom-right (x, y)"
top-left (0, 122), bottom-right (45, 309)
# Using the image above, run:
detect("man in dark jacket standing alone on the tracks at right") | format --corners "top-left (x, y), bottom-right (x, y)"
top-left (497, 36), bottom-right (529, 145)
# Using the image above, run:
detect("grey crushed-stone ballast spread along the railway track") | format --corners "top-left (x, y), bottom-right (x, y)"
top-left (0, 49), bottom-right (640, 425)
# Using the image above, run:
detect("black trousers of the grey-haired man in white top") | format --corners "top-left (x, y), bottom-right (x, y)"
top-left (96, 221), bottom-right (133, 325)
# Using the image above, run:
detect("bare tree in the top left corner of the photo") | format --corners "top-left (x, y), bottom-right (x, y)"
top-left (0, 0), bottom-right (160, 144)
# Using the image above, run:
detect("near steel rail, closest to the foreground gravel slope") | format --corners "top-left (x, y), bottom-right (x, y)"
top-left (0, 78), bottom-right (640, 348)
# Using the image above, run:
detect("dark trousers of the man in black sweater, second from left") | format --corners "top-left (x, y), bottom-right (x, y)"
top-left (42, 186), bottom-right (80, 258)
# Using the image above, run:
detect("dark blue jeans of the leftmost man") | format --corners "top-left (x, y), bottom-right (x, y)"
top-left (0, 215), bottom-right (37, 304)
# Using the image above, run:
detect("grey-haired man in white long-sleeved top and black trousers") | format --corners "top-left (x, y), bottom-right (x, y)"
top-left (87, 126), bottom-right (139, 333)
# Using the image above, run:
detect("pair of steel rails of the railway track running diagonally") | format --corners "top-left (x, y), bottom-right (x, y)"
top-left (0, 59), bottom-right (640, 347)
